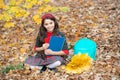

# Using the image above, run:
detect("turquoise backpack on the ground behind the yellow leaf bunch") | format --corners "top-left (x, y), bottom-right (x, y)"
top-left (74, 38), bottom-right (97, 60)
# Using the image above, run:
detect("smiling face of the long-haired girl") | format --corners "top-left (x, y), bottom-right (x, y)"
top-left (43, 19), bottom-right (55, 32)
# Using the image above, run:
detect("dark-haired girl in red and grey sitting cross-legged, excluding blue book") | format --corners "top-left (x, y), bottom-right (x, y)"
top-left (25, 14), bottom-right (69, 72)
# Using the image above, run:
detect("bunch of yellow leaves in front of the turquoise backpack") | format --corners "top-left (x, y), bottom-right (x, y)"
top-left (65, 54), bottom-right (92, 73)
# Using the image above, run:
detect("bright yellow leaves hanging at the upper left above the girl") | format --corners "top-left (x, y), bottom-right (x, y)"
top-left (0, 0), bottom-right (68, 28)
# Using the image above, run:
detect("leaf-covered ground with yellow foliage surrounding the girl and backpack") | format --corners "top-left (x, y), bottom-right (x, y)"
top-left (0, 0), bottom-right (120, 80)
